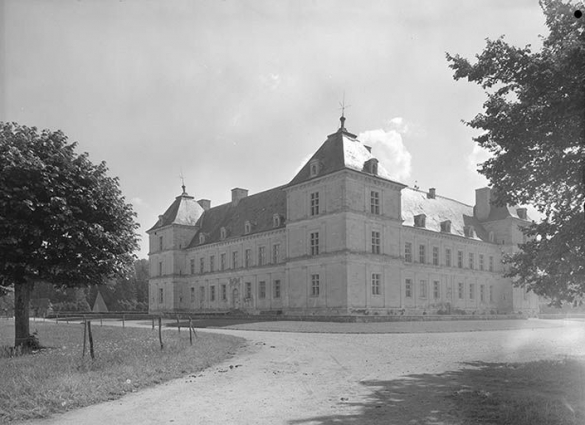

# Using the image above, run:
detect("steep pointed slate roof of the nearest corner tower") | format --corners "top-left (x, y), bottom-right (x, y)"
top-left (289, 126), bottom-right (396, 186)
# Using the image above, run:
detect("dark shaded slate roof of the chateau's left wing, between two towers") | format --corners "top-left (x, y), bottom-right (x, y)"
top-left (189, 186), bottom-right (286, 248)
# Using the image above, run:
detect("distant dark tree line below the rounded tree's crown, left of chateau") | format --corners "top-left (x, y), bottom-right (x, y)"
top-left (31, 260), bottom-right (148, 312)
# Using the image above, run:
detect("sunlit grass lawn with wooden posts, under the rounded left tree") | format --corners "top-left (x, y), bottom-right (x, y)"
top-left (0, 319), bottom-right (244, 423)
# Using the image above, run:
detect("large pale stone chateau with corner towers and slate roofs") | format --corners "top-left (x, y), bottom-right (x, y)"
top-left (147, 117), bottom-right (538, 315)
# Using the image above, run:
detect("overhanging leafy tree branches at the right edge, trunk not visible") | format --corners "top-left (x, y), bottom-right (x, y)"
top-left (447, 0), bottom-right (585, 304)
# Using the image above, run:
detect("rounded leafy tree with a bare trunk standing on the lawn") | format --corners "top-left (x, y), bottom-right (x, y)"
top-left (0, 123), bottom-right (138, 347)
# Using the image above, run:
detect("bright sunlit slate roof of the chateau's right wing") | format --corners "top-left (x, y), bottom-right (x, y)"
top-left (402, 187), bottom-right (488, 241)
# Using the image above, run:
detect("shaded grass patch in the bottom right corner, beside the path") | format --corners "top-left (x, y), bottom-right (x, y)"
top-left (449, 358), bottom-right (585, 425)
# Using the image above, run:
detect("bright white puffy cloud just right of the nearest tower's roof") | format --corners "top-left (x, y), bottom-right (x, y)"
top-left (358, 124), bottom-right (412, 181)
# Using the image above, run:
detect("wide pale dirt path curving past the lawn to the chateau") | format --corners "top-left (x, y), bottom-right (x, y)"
top-left (20, 321), bottom-right (585, 425)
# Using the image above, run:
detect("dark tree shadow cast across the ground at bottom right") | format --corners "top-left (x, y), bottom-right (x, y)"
top-left (288, 358), bottom-right (585, 425)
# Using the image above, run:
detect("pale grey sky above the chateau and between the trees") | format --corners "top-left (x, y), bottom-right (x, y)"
top-left (0, 0), bottom-right (547, 258)
